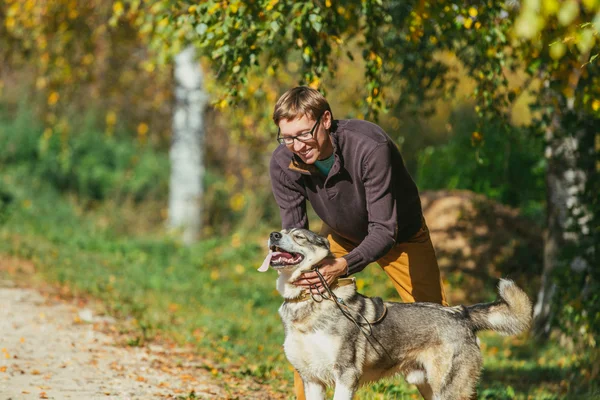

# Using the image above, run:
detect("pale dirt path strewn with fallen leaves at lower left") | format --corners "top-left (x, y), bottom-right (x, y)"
top-left (0, 281), bottom-right (269, 400)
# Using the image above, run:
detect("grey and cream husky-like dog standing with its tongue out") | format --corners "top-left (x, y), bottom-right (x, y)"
top-left (258, 229), bottom-right (532, 400)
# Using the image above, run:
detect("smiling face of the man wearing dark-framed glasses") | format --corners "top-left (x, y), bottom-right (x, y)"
top-left (279, 111), bottom-right (333, 164)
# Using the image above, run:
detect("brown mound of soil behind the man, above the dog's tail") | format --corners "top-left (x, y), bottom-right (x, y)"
top-left (421, 190), bottom-right (543, 304)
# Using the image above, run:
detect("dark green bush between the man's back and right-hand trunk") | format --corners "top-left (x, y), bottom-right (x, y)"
top-left (416, 111), bottom-right (545, 219)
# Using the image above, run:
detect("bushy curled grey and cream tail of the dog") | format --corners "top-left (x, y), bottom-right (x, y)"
top-left (467, 279), bottom-right (532, 335)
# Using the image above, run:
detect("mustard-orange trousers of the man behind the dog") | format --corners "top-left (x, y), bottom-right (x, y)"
top-left (294, 220), bottom-right (448, 400)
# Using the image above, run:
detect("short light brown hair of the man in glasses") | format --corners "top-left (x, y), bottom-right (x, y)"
top-left (273, 86), bottom-right (333, 125)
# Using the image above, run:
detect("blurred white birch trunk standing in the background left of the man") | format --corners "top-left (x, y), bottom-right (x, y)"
top-left (168, 46), bottom-right (208, 245)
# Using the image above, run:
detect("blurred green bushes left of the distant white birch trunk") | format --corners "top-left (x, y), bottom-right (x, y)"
top-left (0, 107), bottom-right (169, 201)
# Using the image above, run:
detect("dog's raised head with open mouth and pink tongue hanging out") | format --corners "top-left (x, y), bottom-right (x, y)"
top-left (258, 229), bottom-right (331, 272)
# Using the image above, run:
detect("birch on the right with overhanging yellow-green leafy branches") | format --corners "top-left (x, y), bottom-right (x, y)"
top-left (124, 0), bottom-right (600, 368)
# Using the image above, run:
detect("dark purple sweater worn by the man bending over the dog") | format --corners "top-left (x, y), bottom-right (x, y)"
top-left (270, 120), bottom-right (422, 274)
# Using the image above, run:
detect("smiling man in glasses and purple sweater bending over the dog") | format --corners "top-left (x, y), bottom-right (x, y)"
top-left (270, 87), bottom-right (447, 399)
